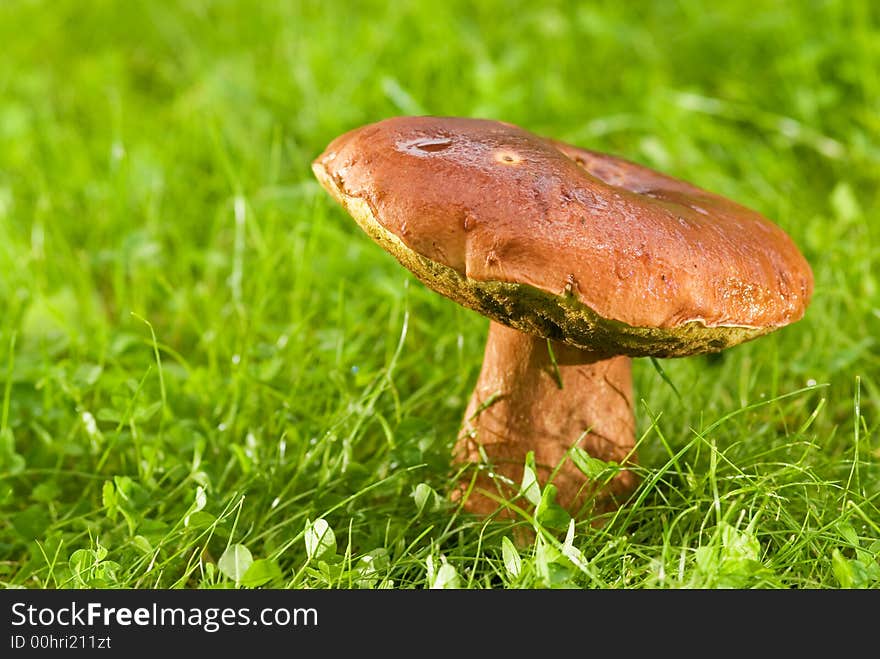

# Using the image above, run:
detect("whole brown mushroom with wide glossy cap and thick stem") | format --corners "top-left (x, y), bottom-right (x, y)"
top-left (312, 117), bottom-right (813, 515)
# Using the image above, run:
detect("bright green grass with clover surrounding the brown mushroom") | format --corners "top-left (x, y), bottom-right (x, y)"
top-left (0, 0), bottom-right (880, 588)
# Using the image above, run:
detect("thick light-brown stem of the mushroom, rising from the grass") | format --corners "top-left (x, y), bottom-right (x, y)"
top-left (454, 321), bottom-right (636, 514)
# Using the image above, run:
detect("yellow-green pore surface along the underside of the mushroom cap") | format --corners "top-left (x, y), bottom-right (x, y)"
top-left (313, 163), bottom-right (776, 357)
